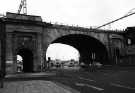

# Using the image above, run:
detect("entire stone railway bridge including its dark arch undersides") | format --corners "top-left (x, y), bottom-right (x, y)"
top-left (0, 12), bottom-right (133, 73)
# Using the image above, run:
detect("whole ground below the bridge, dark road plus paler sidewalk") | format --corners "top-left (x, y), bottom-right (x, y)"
top-left (0, 67), bottom-right (135, 93)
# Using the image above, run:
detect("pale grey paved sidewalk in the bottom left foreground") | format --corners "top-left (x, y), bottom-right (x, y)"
top-left (0, 80), bottom-right (79, 93)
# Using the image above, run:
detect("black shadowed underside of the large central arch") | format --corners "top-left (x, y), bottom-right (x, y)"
top-left (52, 34), bottom-right (109, 64)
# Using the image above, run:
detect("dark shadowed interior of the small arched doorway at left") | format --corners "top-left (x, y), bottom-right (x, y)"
top-left (17, 48), bottom-right (33, 73)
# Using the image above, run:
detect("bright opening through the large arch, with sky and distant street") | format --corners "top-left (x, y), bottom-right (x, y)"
top-left (46, 43), bottom-right (80, 68)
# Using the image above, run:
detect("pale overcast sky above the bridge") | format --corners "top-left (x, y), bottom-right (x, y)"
top-left (0, 0), bottom-right (135, 29)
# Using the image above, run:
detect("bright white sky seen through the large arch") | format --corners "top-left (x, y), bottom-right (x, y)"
top-left (46, 43), bottom-right (80, 61)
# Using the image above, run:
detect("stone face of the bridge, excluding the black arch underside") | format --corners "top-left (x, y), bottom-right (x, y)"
top-left (0, 13), bottom-right (135, 73)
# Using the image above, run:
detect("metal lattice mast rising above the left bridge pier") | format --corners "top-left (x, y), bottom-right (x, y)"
top-left (17, 0), bottom-right (27, 15)
